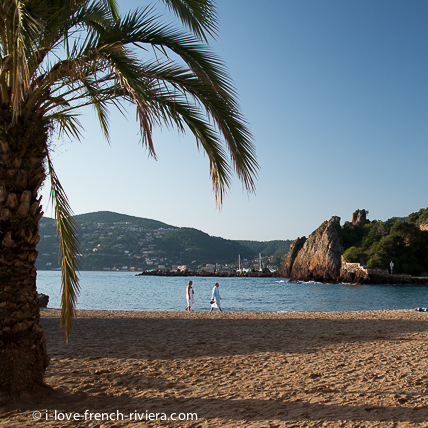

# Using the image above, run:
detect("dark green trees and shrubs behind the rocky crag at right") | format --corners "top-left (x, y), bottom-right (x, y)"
top-left (341, 208), bottom-right (428, 276)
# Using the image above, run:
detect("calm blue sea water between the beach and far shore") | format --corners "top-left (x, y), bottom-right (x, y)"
top-left (37, 271), bottom-right (428, 312)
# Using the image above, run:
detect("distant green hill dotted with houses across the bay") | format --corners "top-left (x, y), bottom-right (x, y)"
top-left (36, 211), bottom-right (291, 271)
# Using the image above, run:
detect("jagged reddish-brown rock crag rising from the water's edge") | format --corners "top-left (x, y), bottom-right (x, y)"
top-left (278, 216), bottom-right (344, 282)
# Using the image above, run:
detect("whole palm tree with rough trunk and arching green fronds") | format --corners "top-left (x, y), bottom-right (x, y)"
top-left (0, 0), bottom-right (258, 394)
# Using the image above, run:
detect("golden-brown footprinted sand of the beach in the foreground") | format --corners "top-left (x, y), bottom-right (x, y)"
top-left (0, 309), bottom-right (428, 427)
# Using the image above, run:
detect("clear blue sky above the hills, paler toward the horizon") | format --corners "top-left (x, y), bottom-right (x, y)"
top-left (38, 0), bottom-right (428, 240)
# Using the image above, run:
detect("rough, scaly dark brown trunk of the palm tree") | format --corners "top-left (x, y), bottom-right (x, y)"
top-left (0, 113), bottom-right (49, 395)
